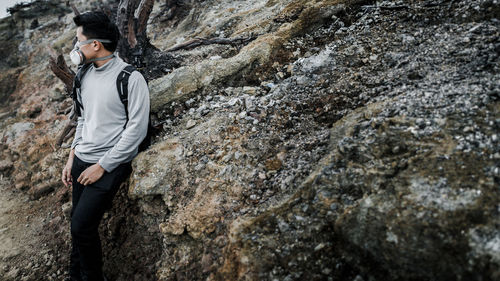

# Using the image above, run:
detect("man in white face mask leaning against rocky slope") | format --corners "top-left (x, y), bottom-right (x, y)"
top-left (62, 12), bottom-right (149, 281)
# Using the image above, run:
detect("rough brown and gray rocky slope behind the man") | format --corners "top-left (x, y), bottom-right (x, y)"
top-left (0, 0), bottom-right (500, 280)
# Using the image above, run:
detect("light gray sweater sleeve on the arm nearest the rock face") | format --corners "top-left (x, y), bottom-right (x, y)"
top-left (99, 71), bottom-right (149, 172)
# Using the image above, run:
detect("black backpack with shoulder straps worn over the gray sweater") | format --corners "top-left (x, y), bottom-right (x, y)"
top-left (71, 63), bottom-right (155, 152)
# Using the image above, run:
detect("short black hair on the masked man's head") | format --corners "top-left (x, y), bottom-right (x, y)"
top-left (73, 12), bottom-right (120, 52)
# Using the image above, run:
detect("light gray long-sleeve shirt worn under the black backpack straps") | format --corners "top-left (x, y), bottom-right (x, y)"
top-left (71, 57), bottom-right (149, 172)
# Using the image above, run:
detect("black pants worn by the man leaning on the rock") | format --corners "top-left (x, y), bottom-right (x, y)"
top-left (70, 156), bottom-right (132, 281)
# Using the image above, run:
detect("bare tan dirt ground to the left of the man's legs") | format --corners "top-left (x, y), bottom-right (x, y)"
top-left (0, 176), bottom-right (69, 281)
